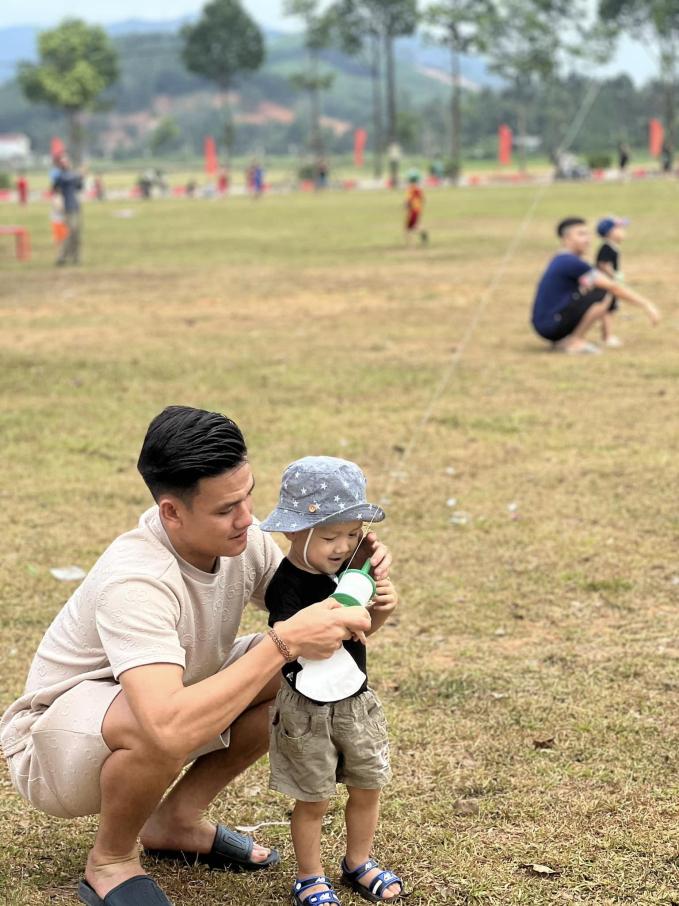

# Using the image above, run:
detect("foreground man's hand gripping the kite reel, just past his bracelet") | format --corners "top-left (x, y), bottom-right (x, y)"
top-left (276, 598), bottom-right (370, 660)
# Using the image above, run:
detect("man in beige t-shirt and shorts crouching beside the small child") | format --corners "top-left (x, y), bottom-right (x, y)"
top-left (0, 406), bottom-right (382, 906)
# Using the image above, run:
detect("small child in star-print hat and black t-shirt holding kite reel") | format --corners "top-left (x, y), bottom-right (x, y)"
top-left (261, 456), bottom-right (405, 906)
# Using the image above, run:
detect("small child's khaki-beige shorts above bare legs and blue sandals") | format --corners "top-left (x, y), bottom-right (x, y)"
top-left (269, 680), bottom-right (391, 802)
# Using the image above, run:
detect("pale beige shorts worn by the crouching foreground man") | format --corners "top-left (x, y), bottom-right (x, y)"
top-left (8, 633), bottom-right (261, 818)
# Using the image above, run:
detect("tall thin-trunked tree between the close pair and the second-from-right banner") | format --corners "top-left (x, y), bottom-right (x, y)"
top-left (424, 0), bottom-right (494, 179)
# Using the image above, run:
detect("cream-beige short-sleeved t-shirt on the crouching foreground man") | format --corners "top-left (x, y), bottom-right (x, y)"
top-left (0, 506), bottom-right (282, 757)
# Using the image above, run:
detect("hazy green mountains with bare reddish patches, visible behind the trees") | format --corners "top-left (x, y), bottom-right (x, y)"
top-left (0, 19), bottom-right (495, 156)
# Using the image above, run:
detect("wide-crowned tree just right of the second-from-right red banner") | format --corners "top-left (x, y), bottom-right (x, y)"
top-left (486, 0), bottom-right (594, 169)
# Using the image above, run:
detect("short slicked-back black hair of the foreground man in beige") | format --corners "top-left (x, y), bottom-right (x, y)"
top-left (137, 406), bottom-right (248, 502)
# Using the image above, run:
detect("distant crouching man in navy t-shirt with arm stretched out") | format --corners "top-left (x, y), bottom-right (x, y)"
top-left (532, 217), bottom-right (660, 355)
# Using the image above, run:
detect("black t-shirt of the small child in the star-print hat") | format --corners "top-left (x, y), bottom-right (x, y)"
top-left (264, 557), bottom-right (368, 704)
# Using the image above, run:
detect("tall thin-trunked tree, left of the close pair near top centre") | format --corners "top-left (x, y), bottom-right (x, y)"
top-left (329, 0), bottom-right (384, 179)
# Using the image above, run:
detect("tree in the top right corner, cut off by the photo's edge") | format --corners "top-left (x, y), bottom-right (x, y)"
top-left (599, 0), bottom-right (679, 155)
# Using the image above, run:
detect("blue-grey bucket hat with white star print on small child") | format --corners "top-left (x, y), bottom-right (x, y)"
top-left (260, 456), bottom-right (384, 532)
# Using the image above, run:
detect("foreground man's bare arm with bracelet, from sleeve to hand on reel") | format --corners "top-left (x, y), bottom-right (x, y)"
top-left (120, 601), bottom-right (370, 758)
